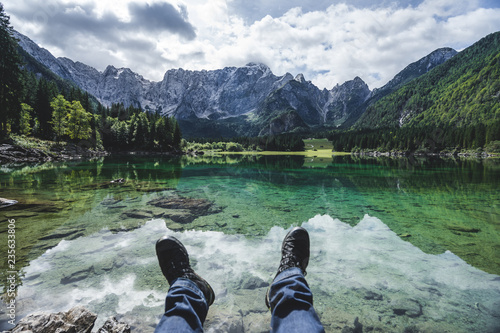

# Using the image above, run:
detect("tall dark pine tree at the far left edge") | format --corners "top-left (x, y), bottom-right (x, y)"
top-left (0, 3), bottom-right (22, 137)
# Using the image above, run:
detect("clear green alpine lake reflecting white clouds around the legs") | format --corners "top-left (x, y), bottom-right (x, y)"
top-left (0, 155), bottom-right (500, 332)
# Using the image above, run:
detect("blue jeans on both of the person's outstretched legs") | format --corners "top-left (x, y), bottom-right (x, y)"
top-left (155, 268), bottom-right (325, 333)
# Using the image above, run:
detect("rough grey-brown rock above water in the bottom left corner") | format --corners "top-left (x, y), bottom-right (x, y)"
top-left (11, 306), bottom-right (97, 333)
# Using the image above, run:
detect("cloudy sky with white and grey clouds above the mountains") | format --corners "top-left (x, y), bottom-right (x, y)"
top-left (0, 0), bottom-right (500, 89)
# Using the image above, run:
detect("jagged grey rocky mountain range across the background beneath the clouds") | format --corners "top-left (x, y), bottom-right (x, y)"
top-left (14, 32), bottom-right (457, 137)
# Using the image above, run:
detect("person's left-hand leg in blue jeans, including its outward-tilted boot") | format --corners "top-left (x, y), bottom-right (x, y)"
top-left (155, 237), bottom-right (215, 333)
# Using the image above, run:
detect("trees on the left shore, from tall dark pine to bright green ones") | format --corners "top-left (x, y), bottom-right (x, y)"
top-left (0, 3), bottom-right (182, 150)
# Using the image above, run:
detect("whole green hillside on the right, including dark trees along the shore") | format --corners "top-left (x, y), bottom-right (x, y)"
top-left (331, 32), bottom-right (500, 150)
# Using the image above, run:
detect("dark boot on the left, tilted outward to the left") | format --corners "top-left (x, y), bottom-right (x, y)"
top-left (156, 236), bottom-right (215, 306)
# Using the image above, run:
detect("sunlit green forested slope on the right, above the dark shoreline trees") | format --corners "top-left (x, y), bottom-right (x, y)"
top-left (355, 32), bottom-right (500, 128)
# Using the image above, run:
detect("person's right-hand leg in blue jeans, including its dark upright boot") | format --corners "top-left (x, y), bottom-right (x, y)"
top-left (266, 227), bottom-right (325, 333)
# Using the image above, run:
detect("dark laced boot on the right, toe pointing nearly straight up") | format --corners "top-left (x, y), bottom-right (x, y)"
top-left (266, 227), bottom-right (310, 308)
